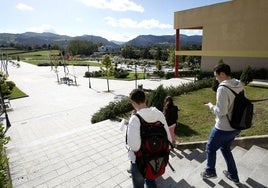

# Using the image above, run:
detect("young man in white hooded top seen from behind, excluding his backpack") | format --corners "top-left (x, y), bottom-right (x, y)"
top-left (127, 89), bottom-right (171, 188)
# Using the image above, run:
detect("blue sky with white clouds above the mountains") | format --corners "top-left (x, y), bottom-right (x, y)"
top-left (0, 0), bottom-right (229, 42)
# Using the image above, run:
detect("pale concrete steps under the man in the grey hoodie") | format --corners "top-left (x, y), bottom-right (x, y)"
top-left (157, 145), bottom-right (268, 188)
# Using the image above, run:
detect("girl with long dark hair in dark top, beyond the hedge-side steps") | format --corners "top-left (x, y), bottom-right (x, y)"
top-left (163, 96), bottom-right (179, 144)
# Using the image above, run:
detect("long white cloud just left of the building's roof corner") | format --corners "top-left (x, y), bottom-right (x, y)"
top-left (104, 17), bottom-right (173, 29)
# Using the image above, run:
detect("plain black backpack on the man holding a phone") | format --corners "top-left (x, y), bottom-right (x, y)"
top-left (221, 85), bottom-right (253, 130)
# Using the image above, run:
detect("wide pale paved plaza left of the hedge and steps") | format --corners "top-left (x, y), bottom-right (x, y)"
top-left (4, 62), bottom-right (193, 188)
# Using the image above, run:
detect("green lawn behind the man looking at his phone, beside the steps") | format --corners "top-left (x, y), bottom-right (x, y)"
top-left (174, 85), bottom-right (268, 142)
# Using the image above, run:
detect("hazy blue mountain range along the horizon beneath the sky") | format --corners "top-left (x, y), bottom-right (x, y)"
top-left (0, 32), bottom-right (202, 47)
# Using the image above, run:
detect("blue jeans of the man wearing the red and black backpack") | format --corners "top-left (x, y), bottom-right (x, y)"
top-left (131, 163), bottom-right (156, 188)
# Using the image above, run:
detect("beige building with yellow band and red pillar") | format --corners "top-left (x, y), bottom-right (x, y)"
top-left (174, 0), bottom-right (268, 74)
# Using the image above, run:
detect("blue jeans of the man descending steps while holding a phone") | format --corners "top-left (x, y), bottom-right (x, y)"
top-left (206, 127), bottom-right (240, 179)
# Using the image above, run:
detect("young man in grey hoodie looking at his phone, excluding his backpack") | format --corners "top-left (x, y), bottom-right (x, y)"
top-left (201, 63), bottom-right (243, 184)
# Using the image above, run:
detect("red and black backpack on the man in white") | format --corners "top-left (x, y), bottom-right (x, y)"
top-left (135, 114), bottom-right (174, 180)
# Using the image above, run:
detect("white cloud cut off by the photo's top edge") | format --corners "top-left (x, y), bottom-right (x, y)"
top-left (80, 0), bottom-right (144, 12)
